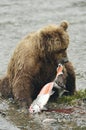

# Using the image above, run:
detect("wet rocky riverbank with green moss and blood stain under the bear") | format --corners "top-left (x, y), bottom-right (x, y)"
top-left (0, 90), bottom-right (86, 130)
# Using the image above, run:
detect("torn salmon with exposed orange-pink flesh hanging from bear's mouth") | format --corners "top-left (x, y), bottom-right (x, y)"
top-left (29, 64), bottom-right (65, 113)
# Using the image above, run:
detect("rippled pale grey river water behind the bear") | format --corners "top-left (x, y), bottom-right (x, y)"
top-left (0, 0), bottom-right (86, 130)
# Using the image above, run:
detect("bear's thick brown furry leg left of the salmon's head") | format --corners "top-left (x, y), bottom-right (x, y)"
top-left (12, 76), bottom-right (33, 107)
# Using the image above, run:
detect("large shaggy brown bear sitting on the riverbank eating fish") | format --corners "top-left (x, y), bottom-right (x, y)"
top-left (0, 21), bottom-right (76, 105)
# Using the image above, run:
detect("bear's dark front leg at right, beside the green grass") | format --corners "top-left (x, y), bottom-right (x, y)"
top-left (65, 62), bottom-right (76, 95)
